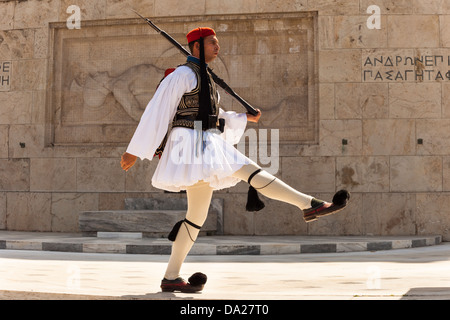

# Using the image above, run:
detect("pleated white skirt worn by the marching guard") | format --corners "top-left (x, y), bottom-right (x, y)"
top-left (152, 127), bottom-right (252, 192)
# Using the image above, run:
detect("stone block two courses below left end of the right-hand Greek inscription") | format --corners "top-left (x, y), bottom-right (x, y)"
top-left (363, 119), bottom-right (416, 155)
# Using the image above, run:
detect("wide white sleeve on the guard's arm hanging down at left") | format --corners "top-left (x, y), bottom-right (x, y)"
top-left (127, 66), bottom-right (197, 160)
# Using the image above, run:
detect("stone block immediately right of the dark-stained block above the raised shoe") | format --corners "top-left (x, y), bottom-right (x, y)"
top-left (390, 156), bottom-right (443, 192)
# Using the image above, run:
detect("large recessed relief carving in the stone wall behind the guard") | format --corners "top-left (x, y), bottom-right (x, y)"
top-left (47, 13), bottom-right (317, 146)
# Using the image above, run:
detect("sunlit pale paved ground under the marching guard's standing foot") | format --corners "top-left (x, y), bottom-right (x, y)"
top-left (0, 232), bottom-right (450, 302)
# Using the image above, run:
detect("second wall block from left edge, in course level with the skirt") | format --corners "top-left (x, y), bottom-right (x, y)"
top-left (30, 158), bottom-right (77, 191)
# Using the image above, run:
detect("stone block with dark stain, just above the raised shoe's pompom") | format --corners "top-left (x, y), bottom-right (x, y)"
top-left (336, 157), bottom-right (389, 192)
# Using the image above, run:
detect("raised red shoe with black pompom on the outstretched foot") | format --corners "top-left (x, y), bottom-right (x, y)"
top-left (303, 190), bottom-right (350, 222)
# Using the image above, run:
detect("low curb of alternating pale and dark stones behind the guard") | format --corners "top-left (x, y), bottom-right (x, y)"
top-left (0, 231), bottom-right (442, 255)
